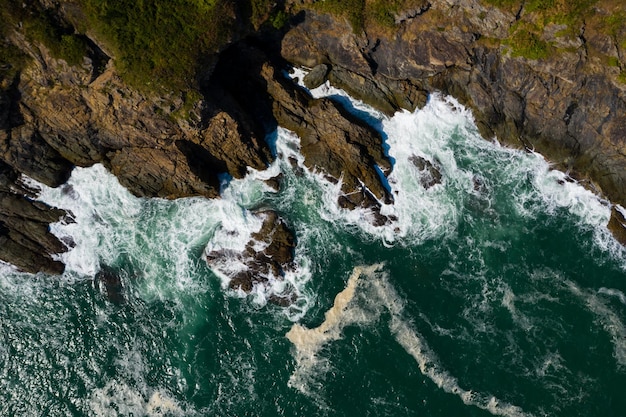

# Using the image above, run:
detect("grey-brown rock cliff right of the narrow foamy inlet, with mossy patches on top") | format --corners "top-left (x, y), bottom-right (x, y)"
top-left (282, 0), bottom-right (626, 214)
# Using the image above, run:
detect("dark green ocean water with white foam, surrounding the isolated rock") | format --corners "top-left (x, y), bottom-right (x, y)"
top-left (0, 86), bottom-right (626, 417)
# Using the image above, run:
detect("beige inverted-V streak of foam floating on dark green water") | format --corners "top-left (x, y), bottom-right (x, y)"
top-left (286, 264), bottom-right (531, 417)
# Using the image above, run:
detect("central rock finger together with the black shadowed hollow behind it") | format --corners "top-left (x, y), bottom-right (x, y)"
top-left (208, 42), bottom-right (391, 214)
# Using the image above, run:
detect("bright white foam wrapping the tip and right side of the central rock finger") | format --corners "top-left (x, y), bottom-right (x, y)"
top-left (288, 70), bottom-right (476, 244)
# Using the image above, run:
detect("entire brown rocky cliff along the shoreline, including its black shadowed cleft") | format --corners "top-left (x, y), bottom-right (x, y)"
top-left (0, 0), bottom-right (626, 273)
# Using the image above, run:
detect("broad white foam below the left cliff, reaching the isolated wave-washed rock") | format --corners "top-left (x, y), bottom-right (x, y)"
top-left (33, 165), bottom-right (310, 320)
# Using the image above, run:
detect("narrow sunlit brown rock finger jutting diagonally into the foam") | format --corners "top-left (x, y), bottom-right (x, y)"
top-left (261, 59), bottom-right (391, 205)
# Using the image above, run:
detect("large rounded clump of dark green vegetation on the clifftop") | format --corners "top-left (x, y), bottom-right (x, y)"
top-left (80, 0), bottom-right (233, 90)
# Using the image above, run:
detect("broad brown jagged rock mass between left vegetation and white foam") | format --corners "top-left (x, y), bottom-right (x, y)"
top-left (0, 32), bottom-right (271, 202)
